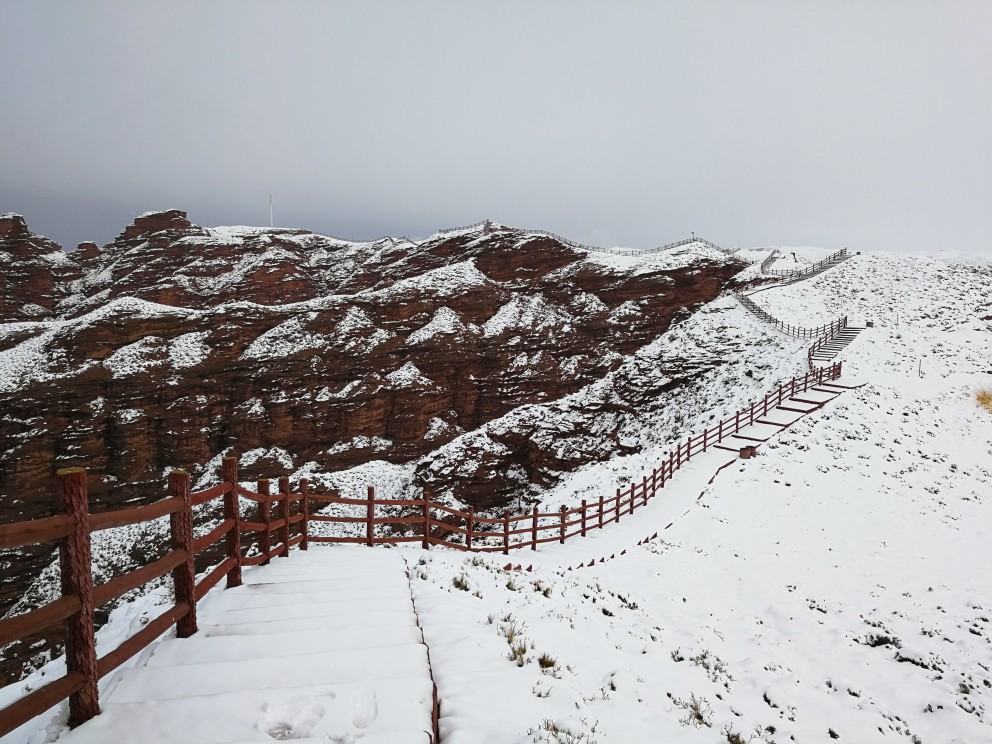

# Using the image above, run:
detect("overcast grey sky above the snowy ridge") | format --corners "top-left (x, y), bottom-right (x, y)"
top-left (0, 0), bottom-right (992, 251)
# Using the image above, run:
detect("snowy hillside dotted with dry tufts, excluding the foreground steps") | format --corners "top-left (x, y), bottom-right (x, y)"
top-left (3, 247), bottom-right (992, 744)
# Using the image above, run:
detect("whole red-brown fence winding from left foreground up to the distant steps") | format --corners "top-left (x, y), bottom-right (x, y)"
top-left (0, 363), bottom-right (841, 736)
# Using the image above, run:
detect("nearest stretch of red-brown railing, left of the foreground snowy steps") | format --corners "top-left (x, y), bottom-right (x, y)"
top-left (0, 458), bottom-right (307, 736)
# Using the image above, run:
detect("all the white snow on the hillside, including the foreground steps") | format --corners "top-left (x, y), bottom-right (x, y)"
top-left (0, 249), bottom-right (992, 744)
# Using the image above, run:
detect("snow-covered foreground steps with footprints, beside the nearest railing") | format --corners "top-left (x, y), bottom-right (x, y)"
top-left (60, 546), bottom-right (434, 744)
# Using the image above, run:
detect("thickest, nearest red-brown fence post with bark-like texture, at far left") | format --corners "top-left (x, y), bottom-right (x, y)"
top-left (55, 468), bottom-right (100, 728)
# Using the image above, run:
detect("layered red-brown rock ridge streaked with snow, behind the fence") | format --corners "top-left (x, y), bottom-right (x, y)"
top-left (0, 210), bottom-right (741, 684)
